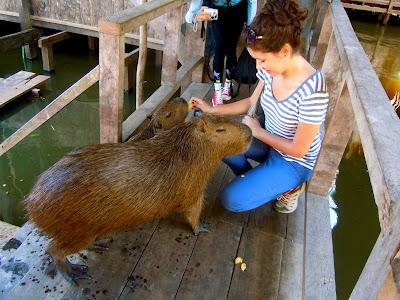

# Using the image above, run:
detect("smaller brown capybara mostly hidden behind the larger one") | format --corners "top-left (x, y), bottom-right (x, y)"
top-left (127, 97), bottom-right (188, 142)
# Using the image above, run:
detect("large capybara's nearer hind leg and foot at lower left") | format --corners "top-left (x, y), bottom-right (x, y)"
top-left (46, 240), bottom-right (91, 284)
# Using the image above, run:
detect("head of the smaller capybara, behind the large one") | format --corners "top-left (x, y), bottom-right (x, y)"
top-left (151, 97), bottom-right (188, 133)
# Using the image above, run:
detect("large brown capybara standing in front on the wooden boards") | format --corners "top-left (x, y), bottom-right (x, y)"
top-left (25, 115), bottom-right (251, 281)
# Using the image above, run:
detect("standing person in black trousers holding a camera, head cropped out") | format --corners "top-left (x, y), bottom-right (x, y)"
top-left (185, 0), bottom-right (257, 106)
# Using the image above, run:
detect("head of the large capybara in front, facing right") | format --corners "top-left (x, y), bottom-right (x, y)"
top-left (194, 114), bottom-right (252, 156)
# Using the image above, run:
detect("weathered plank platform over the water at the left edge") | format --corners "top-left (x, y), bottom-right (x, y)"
top-left (0, 71), bottom-right (50, 107)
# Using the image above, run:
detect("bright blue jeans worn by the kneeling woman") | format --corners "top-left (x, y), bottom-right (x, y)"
top-left (220, 138), bottom-right (312, 212)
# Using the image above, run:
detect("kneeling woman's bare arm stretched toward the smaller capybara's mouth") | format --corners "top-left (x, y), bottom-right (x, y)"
top-left (190, 80), bottom-right (264, 115)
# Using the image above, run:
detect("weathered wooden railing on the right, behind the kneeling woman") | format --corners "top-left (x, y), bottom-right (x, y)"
top-left (308, 0), bottom-right (400, 299)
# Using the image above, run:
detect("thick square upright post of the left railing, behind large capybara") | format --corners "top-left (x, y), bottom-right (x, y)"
top-left (99, 33), bottom-right (125, 143)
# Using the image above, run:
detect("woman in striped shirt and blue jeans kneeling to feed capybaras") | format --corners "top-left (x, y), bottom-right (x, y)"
top-left (191, 0), bottom-right (329, 213)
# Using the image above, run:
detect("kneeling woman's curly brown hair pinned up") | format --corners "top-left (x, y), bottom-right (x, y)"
top-left (246, 0), bottom-right (308, 52)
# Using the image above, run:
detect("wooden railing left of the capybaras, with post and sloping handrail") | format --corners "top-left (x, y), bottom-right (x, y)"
top-left (0, 0), bottom-right (204, 156)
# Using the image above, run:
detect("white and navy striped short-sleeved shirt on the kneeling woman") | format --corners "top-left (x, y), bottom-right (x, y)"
top-left (257, 69), bottom-right (329, 169)
